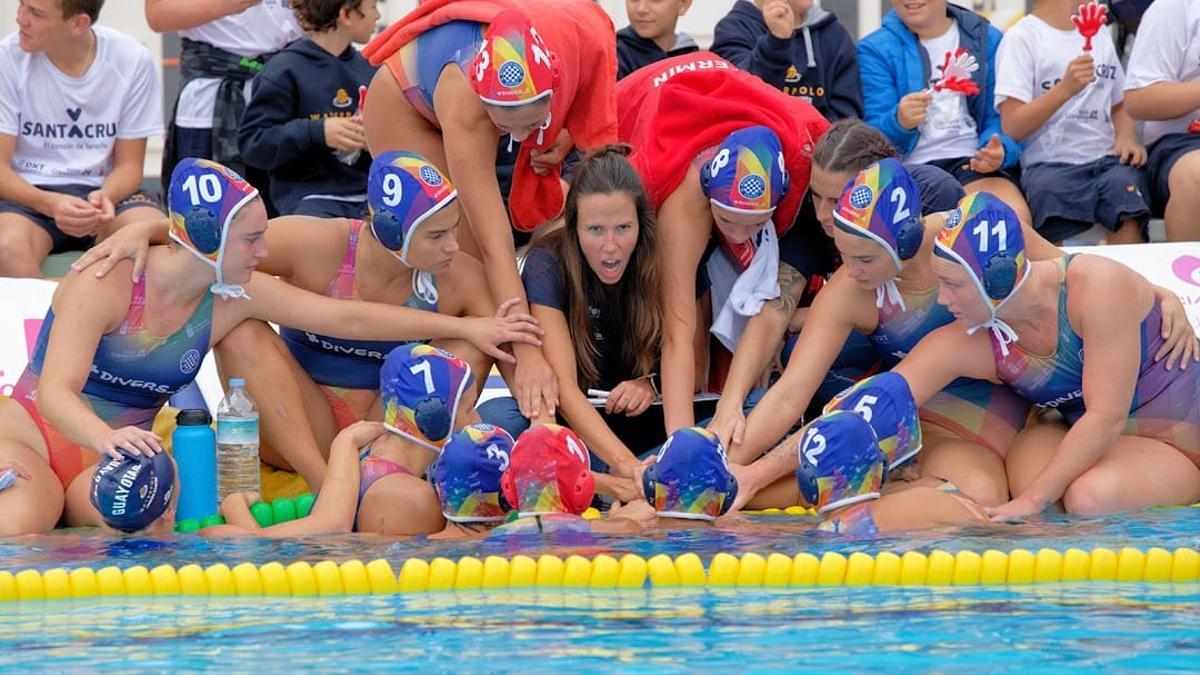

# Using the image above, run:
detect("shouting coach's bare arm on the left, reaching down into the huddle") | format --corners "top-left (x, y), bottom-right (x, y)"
top-left (533, 305), bottom-right (637, 476)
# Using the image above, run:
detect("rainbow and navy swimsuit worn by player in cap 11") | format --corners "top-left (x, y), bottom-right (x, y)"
top-left (992, 256), bottom-right (1200, 458)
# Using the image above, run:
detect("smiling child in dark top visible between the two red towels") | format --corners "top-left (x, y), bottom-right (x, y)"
top-left (617, 0), bottom-right (700, 79)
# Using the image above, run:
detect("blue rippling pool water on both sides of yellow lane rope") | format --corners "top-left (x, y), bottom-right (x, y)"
top-left (0, 508), bottom-right (1200, 671)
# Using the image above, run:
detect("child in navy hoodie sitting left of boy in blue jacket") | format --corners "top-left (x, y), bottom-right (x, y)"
top-left (713, 0), bottom-right (863, 121)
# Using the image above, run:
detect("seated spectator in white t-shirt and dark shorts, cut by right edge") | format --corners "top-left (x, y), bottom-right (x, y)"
top-left (1126, 0), bottom-right (1200, 241)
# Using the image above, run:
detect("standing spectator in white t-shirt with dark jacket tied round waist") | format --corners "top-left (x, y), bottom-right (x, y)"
top-left (145, 0), bottom-right (302, 190)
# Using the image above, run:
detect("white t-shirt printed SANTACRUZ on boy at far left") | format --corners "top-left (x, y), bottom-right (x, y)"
top-left (0, 26), bottom-right (162, 187)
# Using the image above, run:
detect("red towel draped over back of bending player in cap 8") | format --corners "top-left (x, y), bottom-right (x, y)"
top-left (617, 52), bottom-right (829, 267)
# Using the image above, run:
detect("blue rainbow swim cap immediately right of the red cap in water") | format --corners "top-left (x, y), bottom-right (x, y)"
top-left (642, 426), bottom-right (738, 521)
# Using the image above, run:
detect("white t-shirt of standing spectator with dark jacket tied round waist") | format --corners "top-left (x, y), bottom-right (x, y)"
top-left (175, 0), bottom-right (304, 129)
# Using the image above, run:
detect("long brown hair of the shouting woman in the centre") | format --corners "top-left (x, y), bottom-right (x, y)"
top-left (538, 145), bottom-right (662, 388)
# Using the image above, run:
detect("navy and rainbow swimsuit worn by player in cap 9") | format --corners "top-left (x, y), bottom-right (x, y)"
top-left (280, 220), bottom-right (438, 390)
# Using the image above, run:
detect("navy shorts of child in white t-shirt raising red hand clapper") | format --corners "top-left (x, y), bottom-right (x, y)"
top-left (1021, 155), bottom-right (1150, 243)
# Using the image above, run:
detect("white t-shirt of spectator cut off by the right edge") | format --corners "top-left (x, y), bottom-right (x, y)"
top-left (1126, 0), bottom-right (1200, 144)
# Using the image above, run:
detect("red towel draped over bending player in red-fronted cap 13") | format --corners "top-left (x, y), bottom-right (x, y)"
top-left (362, 0), bottom-right (617, 232)
